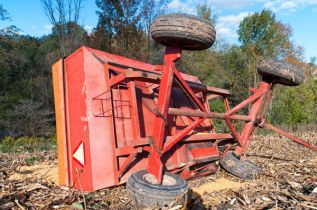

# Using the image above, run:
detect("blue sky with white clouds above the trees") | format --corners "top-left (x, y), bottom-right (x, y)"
top-left (0, 0), bottom-right (317, 60)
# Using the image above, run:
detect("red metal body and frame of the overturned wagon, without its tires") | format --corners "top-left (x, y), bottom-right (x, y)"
top-left (53, 47), bottom-right (317, 191)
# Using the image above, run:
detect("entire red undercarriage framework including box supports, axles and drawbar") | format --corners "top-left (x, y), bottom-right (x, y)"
top-left (99, 47), bottom-right (317, 184)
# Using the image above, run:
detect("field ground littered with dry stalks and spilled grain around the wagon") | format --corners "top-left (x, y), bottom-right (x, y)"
top-left (0, 132), bottom-right (317, 210)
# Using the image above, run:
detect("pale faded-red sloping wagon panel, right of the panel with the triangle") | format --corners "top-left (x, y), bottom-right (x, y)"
top-left (82, 48), bottom-right (115, 190)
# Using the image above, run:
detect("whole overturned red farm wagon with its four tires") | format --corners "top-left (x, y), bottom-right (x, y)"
top-left (53, 14), bottom-right (317, 206)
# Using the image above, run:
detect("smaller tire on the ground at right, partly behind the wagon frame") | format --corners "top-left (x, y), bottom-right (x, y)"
top-left (220, 152), bottom-right (262, 180)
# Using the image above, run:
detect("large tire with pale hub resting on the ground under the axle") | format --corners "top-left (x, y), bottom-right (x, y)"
top-left (126, 170), bottom-right (188, 208)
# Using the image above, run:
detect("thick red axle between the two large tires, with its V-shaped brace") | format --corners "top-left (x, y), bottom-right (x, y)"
top-left (148, 48), bottom-right (225, 184)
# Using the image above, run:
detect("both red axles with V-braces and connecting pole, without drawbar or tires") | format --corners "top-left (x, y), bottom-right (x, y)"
top-left (143, 48), bottom-right (270, 183)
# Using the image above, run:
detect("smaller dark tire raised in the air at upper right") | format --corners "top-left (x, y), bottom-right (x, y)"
top-left (257, 59), bottom-right (305, 86)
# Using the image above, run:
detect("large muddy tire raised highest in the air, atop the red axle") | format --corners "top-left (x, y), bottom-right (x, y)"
top-left (150, 14), bottom-right (216, 51)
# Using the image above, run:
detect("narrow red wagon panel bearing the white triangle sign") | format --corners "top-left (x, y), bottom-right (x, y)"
top-left (65, 48), bottom-right (94, 191)
